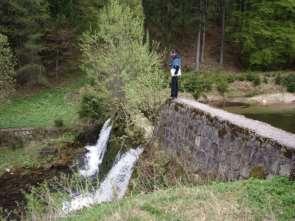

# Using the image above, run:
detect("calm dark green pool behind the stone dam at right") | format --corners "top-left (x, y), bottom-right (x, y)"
top-left (224, 104), bottom-right (295, 133)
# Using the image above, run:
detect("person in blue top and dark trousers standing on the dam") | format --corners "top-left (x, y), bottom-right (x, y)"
top-left (169, 50), bottom-right (181, 99)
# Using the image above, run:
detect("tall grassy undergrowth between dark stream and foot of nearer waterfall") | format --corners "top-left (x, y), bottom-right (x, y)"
top-left (25, 173), bottom-right (99, 221)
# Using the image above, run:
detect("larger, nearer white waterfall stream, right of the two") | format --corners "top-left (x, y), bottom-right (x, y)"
top-left (63, 147), bottom-right (143, 213)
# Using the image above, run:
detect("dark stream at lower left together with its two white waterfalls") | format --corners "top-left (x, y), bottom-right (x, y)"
top-left (0, 119), bottom-right (143, 220)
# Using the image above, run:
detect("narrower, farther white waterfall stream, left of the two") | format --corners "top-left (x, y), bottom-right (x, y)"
top-left (79, 119), bottom-right (112, 177)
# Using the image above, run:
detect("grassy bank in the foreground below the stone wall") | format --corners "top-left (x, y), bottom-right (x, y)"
top-left (61, 177), bottom-right (295, 221)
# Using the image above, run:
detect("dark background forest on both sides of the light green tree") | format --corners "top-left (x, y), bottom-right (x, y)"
top-left (0, 0), bottom-right (295, 100)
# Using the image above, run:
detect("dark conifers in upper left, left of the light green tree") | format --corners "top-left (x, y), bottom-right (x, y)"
top-left (0, 0), bottom-right (105, 85)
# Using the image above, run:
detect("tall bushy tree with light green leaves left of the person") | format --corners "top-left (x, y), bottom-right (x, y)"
top-left (81, 0), bottom-right (164, 121)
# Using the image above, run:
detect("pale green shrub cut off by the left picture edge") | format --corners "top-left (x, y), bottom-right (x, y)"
top-left (0, 34), bottom-right (16, 100)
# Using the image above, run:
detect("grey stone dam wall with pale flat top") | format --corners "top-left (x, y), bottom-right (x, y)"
top-left (155, 98), bottom-right (295, 180)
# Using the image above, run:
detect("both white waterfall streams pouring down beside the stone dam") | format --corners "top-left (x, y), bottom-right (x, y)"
top-left (62, 120), bottom-right (143, 214)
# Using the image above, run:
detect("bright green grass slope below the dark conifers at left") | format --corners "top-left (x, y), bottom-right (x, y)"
top-left (0, 77), bottom-right (85, 128)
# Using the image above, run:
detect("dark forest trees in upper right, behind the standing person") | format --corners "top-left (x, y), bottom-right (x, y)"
top-left (143, 0), bottom-right (295, 70)
